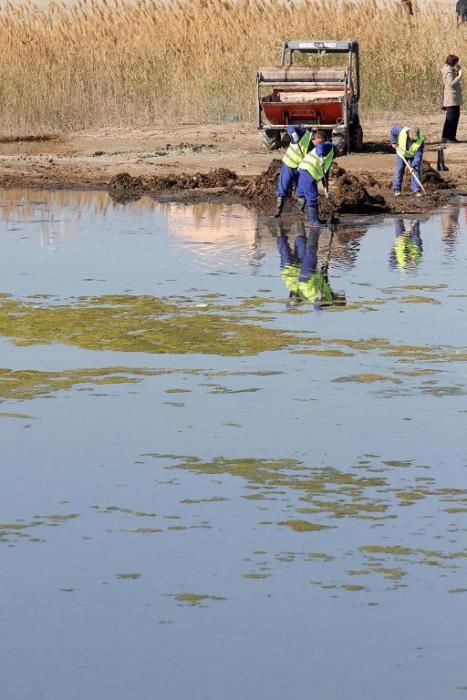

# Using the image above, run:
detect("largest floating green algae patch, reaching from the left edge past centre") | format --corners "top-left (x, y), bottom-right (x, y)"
top-left (0, 295), bottom-right (302, 356)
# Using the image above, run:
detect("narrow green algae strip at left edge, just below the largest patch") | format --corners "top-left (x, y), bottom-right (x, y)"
top-left (0, 367), bottom-right (158, 401)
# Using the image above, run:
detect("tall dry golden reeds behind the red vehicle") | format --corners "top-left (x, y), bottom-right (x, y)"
top-left (0, 0), bottom-right (467, 132)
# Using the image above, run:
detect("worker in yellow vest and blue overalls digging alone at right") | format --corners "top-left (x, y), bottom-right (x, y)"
top-left (389, 124), bottom-right (425, 197)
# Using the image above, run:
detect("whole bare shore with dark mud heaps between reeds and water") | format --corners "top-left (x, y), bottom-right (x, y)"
top-left (0, 120), bottom-right (467, 216)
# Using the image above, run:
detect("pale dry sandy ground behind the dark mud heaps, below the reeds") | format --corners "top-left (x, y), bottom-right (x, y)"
top-left (0, 112), bottom-right (467, 208)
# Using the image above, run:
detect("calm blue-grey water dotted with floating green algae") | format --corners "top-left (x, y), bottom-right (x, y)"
top-left (0, 191), bottom-right (467, 700)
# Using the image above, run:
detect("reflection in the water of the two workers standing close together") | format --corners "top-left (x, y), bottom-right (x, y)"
top-left (277, 224), bottom-right (346, 308)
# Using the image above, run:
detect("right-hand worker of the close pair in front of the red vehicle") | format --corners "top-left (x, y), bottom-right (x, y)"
top-left (296, 131), bottom-right (335, 226)
